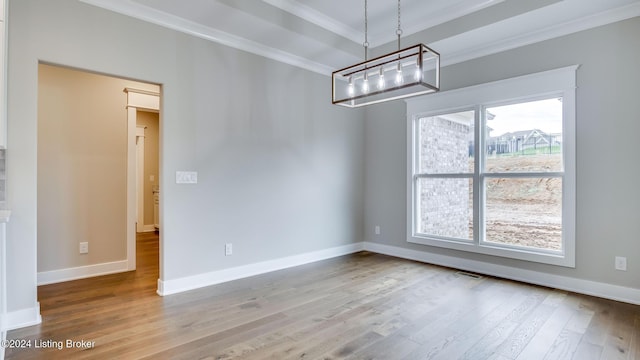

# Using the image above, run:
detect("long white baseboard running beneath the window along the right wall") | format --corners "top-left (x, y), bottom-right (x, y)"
top-left (364, 242), bottom-right (640, 305)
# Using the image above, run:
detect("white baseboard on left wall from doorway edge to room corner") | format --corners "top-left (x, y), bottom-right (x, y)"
top-left (158, 243), bottom-right (364, 296)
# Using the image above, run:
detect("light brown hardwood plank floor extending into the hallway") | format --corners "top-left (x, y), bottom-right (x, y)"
top-left (6, 235), bottom-right (640, 360)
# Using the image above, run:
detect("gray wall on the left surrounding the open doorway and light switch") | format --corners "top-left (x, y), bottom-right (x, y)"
top-left (7, 0), bottom-right (364, 311)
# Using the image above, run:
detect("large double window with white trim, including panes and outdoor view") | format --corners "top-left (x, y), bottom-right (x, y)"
top-left (407, 67), bottom-right (577, 266)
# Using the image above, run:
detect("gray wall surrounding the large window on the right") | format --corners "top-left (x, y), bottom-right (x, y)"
top-left (365, 18), bottom-right (640, 289)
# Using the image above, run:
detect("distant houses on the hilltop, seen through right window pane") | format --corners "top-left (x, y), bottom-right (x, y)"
top-left (486, 129), bottom-right (562, 154)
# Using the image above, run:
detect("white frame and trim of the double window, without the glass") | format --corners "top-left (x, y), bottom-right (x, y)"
top-left (406, 65), bottom-right (579, 267)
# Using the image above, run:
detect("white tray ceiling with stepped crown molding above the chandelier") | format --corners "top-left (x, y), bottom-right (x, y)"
top-left (80, 0), bottom-right (640, 74)
